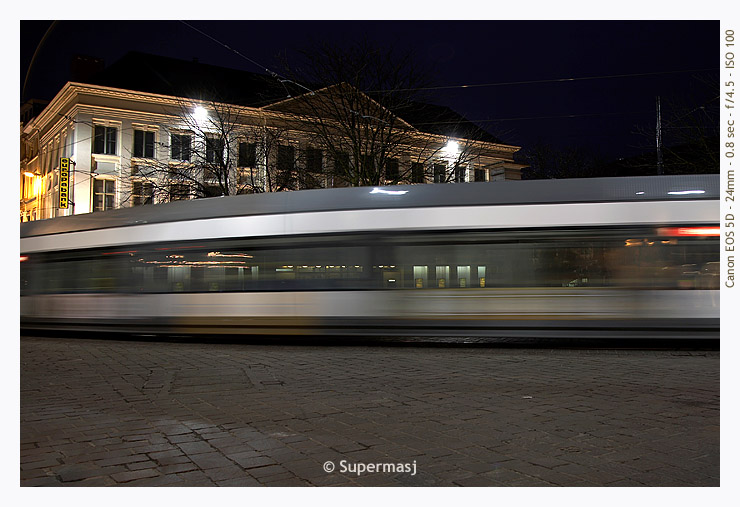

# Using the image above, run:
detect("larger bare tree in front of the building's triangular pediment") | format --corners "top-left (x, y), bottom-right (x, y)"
top-left (266, 42), bottom-right (492, 186)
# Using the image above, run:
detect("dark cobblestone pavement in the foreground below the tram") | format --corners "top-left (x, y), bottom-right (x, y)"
top-left (20, 337), bottom-right (720, 486)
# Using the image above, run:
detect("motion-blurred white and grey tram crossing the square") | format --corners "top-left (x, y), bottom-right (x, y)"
top-left (20, 175), bottom-right (720, 338)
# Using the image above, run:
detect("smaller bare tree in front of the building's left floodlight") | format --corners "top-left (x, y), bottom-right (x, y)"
top-left (123, 100), bottom-right (310, 205)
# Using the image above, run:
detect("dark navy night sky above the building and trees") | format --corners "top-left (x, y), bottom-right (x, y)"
top-left (20, 21), bottom-right (720, 157)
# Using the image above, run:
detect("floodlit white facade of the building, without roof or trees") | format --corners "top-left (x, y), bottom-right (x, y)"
top-left (20, 82), bottom-right (524, 221)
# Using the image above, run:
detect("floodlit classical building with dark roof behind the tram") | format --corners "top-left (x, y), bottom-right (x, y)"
top-left (20, 53), bottom-right (525, 221)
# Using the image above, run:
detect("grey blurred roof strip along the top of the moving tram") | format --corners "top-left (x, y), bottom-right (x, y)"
top-left (20, 175), bottom-right (720, 238)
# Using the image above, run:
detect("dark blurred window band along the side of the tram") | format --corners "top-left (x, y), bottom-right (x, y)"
top-left (21, 229), bottom-right (719, 294)
